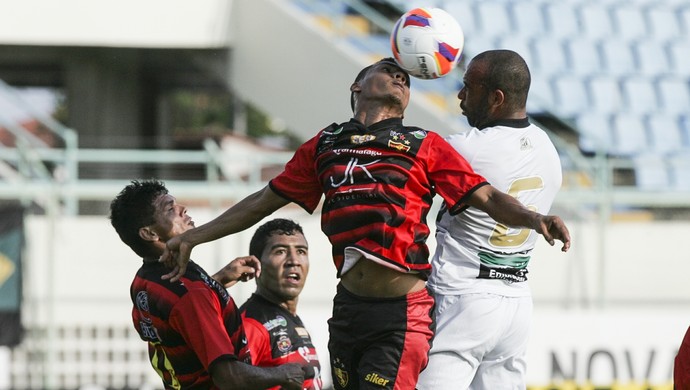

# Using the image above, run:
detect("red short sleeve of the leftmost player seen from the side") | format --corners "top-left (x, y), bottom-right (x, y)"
top-left (170, 289), bottom-right (237, 370)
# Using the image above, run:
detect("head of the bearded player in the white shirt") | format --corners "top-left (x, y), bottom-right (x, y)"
top-left (458, 49), bottom-right (531, 128)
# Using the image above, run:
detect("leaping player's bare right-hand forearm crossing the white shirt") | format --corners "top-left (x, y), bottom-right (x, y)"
top-left (467, 185), bottom-right (570, 252)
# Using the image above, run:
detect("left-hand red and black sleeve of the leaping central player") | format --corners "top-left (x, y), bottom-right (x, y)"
top-left (269, 135), bottom-right (323, 214)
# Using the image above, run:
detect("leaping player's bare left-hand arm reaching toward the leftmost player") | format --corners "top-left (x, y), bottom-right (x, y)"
top-left (160, 186), bottom-right (289, 282)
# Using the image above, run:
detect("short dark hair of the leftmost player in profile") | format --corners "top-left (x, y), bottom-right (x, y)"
top-left (110, 179), bottom-right (168, 257)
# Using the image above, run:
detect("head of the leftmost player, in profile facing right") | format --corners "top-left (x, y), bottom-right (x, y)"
top-left (110, 180), bottom-right (194, 257)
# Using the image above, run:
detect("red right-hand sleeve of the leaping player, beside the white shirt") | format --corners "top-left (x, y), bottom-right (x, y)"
top-left (426, 135), bottom-right (489, 214)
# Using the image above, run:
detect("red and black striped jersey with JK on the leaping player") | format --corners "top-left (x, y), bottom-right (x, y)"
top-left (269, 118), bottom-right (487, 276)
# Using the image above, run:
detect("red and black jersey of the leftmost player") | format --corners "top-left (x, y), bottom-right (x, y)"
top-left (130, 261), bottom-right (251, 389)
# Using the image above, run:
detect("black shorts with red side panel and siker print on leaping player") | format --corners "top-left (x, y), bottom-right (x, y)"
top-left (328, 284), bottom-right (435, 390)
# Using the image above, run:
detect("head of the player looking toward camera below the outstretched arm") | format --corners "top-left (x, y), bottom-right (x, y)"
top-left (249, 218), bottom-right (309, 303)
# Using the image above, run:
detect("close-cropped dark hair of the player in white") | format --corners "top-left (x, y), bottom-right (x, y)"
top-left (472, 49), bottom-right (532, 108)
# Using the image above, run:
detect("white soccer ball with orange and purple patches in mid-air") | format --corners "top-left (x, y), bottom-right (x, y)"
top-left (391, 8), bottom-right (465, 79)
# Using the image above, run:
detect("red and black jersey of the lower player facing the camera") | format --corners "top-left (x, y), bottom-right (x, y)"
top-left (240, 294), bottom-right (323, 390)
